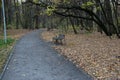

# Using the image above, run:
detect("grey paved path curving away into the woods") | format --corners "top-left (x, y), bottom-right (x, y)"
top-left (2, 30), bottom-right (92, 80)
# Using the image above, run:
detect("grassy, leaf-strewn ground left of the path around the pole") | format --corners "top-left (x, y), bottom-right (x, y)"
top-left (0, 29), bottom-right (29, 72)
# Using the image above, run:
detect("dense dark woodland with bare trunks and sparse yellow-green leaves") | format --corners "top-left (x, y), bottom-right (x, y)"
top-left (0, 0), bottom-right (120, 38)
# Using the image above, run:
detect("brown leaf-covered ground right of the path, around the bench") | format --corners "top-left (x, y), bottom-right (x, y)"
top-left (42, 30), bottom-right (120, 80)
